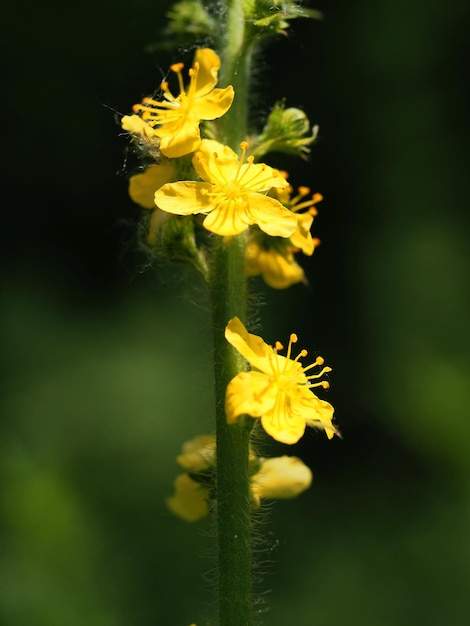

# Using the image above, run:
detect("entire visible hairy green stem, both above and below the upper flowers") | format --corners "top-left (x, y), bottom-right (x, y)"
top-left (210, 0), bottom-right (253, 626)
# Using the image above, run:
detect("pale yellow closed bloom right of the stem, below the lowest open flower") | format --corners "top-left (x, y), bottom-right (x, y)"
top-left (251, 456), bottom-right (313, 503)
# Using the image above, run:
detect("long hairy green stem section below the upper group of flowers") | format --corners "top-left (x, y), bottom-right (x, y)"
top-left (210, 235), bottom-right (253, 626)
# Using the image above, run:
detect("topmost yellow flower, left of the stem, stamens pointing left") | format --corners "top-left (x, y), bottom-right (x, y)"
top-left (121, 48), bottom-right (234, 158)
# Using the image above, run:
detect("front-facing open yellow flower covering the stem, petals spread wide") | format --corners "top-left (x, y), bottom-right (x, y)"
top-left (155, 139), bottom-right (297, 237)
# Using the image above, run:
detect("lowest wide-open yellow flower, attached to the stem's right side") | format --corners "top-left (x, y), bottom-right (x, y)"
top-left (225, 317), bottom-right (339, 444)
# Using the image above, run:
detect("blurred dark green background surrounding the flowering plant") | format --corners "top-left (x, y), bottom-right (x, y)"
top-left (0, 0), bottom-right (470, 626)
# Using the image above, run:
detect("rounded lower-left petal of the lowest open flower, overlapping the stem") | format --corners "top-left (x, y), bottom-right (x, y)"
top-left (225, 372), bottom-right (276, 424)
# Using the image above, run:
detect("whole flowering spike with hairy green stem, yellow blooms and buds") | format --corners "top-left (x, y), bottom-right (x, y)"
top-left (121, 0), bottom-right (339, 626)
